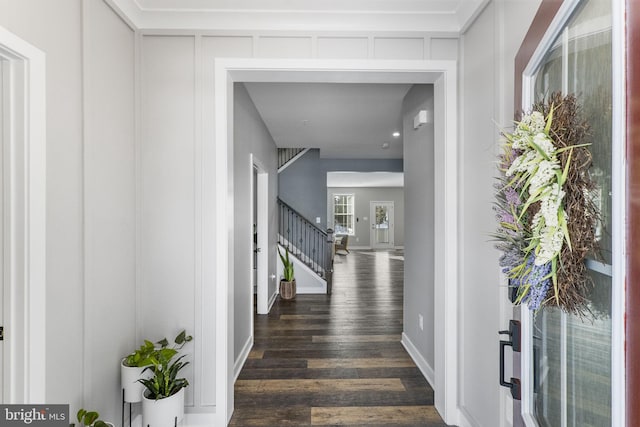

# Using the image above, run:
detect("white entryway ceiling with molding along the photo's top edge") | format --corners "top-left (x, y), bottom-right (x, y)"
top-left (111, 0), bottom-right (489, 34)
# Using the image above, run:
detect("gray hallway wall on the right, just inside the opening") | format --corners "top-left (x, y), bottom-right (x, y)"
top-left (402, 85), bottom-right (435, 378)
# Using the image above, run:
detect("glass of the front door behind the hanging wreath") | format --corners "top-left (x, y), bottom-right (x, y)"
top-left (522, 0), bottom-right (620, 427)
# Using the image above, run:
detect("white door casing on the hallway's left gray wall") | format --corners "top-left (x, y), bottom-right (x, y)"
top-left (249, 153), bottom-right (269, 316)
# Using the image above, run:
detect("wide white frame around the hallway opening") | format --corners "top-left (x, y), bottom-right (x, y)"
top-left (215, 58), bottom-right (459, 425)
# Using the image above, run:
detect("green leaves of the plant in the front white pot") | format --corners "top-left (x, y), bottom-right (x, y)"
top-left (138, 331), bottom-right (193, 400)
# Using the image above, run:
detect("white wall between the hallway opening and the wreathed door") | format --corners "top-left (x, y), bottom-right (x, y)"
top-left (459, 0), bottom-right (540, 426)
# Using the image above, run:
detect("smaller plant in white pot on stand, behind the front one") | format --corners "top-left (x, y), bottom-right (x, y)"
top-left (120, 331), bottom-right (192, 403)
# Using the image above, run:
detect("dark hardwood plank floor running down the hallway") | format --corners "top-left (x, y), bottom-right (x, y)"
top-left (230, 250), bottom-right (446, 427)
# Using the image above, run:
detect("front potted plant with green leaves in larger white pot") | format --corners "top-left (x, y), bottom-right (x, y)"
top-left (138, 331), bottom-right (193, 427)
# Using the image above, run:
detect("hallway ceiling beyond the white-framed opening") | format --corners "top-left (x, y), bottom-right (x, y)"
top-left (245, 83), bottom-right (411, 159)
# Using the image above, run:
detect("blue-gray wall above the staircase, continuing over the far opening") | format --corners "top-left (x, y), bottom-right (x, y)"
top-left (278, 149), bottom-right (403, 230)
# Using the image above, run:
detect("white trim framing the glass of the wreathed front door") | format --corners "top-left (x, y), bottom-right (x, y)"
top-left (519, 0), bottom-right (627, 427)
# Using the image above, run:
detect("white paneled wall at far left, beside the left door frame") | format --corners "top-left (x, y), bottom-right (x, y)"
top-left (0, 0), bottom-right (136, 420)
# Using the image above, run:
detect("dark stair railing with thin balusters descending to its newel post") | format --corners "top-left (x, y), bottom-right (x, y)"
top-left (278, 199), bottom-right (333, 294)
